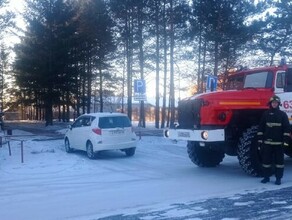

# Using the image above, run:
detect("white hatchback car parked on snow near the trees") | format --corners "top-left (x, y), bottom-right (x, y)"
top-left (65, 112), bottom-right (137, 159)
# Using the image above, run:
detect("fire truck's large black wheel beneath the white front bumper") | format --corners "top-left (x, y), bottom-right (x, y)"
top-left (187, 141), bottom-right (225, 167)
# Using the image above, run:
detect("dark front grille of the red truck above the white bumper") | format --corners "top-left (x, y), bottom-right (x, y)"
top-left (178, 99), bottom-right (202, 129)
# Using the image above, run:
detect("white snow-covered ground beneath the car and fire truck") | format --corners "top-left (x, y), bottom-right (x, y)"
top-left (0, 128), bottom-right (292, 220)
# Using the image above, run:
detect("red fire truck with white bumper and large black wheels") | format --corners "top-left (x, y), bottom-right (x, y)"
top-left (164, 65), bottom-right (292, 176)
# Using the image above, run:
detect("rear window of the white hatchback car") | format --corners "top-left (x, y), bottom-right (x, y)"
top-left (98, 116), bottom-right (132, 129)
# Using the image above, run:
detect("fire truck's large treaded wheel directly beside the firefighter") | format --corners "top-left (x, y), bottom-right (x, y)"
top-left (237, 126), bottom-right (262, 176)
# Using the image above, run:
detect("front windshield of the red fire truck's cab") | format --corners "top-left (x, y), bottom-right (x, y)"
top-left (243, 72), bottom-right (273, 88)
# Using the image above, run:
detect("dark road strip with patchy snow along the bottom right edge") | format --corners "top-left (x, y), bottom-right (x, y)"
top-left (100, 187), bottom-right (292, 220)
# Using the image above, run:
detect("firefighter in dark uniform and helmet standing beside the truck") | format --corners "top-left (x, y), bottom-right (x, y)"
top-left (257, 95), bottom-right (290, 185)
